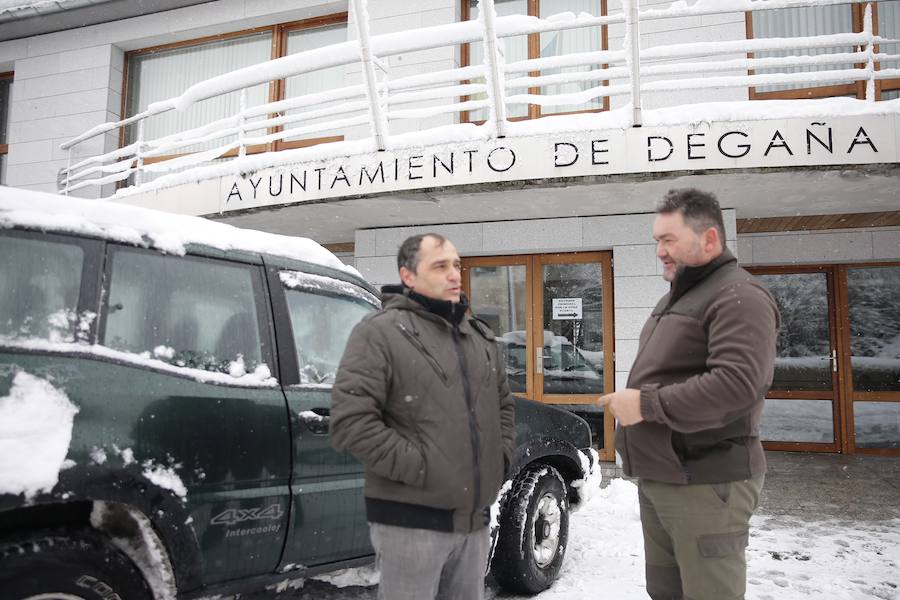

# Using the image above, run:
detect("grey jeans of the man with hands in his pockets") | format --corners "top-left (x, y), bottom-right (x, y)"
top-left (369, 523), bottom-right (490, 600)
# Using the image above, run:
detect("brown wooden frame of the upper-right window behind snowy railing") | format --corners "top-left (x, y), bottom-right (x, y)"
top-left (744, 1), bottom-right (900, 101)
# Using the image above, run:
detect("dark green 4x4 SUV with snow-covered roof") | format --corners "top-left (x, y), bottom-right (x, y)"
top-left (0, 188), bottom-right (596, 600)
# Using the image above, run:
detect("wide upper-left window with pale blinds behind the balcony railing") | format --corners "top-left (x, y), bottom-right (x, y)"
top-left (121, 13), bottom-right (351, 164)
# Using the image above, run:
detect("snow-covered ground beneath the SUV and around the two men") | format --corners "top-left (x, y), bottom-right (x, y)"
top-left (245, 479), bottom-right (900, 600)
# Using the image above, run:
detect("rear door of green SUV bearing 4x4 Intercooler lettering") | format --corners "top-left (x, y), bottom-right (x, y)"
top-left (97, 244), bottom-right (290, 583)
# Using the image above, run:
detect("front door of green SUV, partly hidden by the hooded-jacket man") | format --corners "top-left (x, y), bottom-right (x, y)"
top-left (267, 267), bottom-right (379, 569)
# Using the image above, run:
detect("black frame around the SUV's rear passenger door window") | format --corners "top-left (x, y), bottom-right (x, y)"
top-left (95, 242), bottom-right (279, 380)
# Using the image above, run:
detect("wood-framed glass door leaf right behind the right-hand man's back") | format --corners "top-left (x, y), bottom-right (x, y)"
top-left (755, 268), bottom-right (841, 452)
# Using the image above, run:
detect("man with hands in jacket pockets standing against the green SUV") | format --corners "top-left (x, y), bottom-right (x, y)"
top-left (330, 233), bottom-right (515, 600)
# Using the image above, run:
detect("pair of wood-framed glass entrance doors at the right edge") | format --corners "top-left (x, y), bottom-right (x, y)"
top-left (752, 263), bottom-right (900, 456)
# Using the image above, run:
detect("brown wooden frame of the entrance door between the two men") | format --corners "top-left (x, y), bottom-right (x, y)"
top-left (462, 250), bottom-right (616, 461)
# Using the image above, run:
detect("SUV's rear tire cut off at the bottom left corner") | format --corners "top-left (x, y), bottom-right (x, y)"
top-left (0, 530), bottom-right (153, 600)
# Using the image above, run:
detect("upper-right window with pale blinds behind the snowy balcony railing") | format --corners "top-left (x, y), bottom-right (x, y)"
top-left (747, 2), bottom-right (900, 100)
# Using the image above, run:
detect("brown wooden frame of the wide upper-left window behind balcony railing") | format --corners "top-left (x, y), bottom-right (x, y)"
top-left (122, 12), bottom-right (348, 168)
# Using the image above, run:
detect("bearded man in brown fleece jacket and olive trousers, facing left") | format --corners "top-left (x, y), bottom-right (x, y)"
top-left (600, 189), bottom-right (779, 600)
